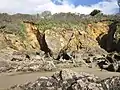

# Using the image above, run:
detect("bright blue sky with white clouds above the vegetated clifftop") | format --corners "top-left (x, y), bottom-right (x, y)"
top-left (0, 0), bottom-right (118, 14)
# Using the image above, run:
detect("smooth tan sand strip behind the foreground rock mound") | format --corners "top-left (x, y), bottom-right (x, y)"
top-left (0, 67), bottom-right (120, 90)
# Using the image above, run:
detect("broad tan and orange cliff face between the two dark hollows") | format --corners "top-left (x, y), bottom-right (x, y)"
top-left (45, 22), bottom-right (108, 56)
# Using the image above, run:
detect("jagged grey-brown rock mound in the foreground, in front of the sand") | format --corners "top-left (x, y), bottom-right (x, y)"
top-left (9, 69), bottom-right (120, 90)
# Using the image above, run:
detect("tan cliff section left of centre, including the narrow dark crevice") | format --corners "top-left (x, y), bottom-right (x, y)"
top-left (0, 21), bottom-right (52, 55)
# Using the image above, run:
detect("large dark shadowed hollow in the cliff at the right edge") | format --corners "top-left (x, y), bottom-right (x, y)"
top-left (96, 21), bottom-right (120, 52)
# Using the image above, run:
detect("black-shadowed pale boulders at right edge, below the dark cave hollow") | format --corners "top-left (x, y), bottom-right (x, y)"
top-left (94, 53), bottom-right (120, 72)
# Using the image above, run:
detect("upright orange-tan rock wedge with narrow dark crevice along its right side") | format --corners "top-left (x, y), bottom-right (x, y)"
top-left (24, 21), bottom-right (52, 56)
